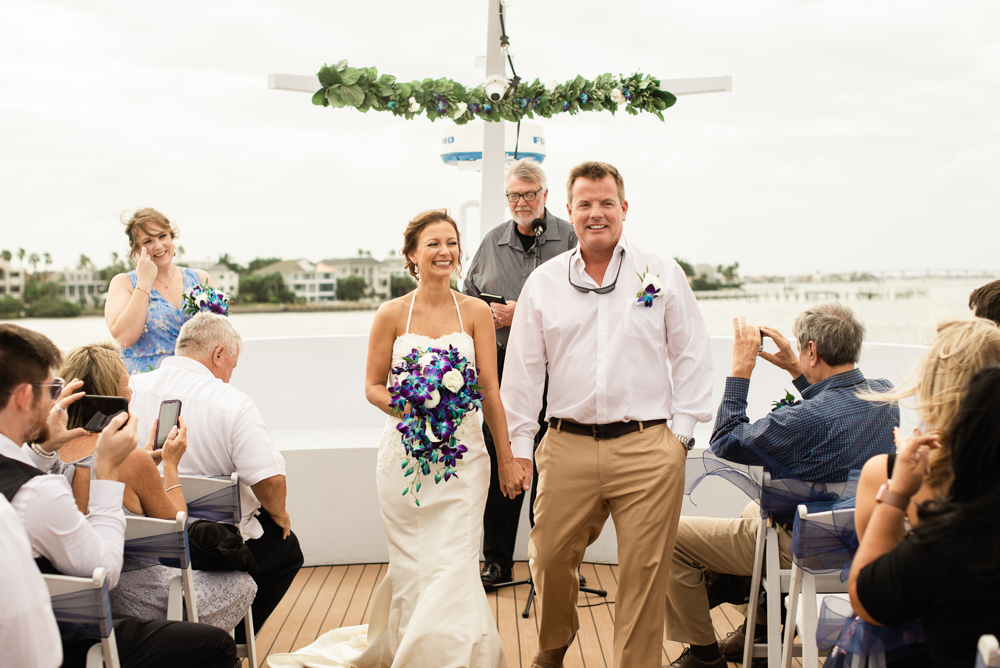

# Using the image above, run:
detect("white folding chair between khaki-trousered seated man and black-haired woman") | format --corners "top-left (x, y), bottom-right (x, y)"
top-left (768, 505), bottom-right (854, 668)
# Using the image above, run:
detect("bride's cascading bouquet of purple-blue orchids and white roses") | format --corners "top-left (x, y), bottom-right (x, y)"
top-left (389, 346), bottom-right (483, 506)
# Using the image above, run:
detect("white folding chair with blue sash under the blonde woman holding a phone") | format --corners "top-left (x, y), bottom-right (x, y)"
top-left (125, 511), bottom-right (198, 622)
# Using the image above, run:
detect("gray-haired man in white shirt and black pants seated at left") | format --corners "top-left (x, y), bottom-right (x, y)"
top-left (130, 313), bottom-right (303, 642)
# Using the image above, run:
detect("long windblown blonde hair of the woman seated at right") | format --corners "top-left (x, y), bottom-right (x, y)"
top-left (860, 318), bottom-right (1000, 489)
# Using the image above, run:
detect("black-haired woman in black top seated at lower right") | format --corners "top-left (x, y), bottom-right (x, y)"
top-left (849, 365), bottom-right (1000, 668)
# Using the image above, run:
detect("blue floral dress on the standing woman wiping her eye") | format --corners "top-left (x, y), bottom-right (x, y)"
top-left (122, 267), bottom-right (201, 375)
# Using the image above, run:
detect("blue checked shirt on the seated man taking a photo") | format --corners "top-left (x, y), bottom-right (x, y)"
top-left (711, 369), bottom-right (899, 482)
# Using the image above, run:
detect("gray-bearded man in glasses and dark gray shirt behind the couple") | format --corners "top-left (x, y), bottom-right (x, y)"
top-left (462, 158), bottom-right (576, 586)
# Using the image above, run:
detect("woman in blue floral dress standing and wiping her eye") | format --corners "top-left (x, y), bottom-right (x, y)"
top-left (104, 209), bottom-right (214, 374)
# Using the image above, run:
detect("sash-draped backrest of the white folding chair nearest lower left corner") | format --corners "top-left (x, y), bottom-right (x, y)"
top-left (43, 568), bottom-right (113, 638)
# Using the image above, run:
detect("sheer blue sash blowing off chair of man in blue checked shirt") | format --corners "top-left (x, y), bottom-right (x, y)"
top-left (684, 442), bottom-right (860, 523)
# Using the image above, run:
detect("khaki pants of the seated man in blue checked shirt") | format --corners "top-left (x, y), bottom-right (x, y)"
top-left (666, 501), bottom-right (792, 645)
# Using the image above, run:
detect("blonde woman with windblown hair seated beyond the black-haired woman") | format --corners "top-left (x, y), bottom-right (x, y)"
top-left (854, 318), bottom-right (1000, 537)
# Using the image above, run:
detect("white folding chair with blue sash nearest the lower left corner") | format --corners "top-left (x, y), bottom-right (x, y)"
top-left (42, 568), bottom-right (120, 668)
